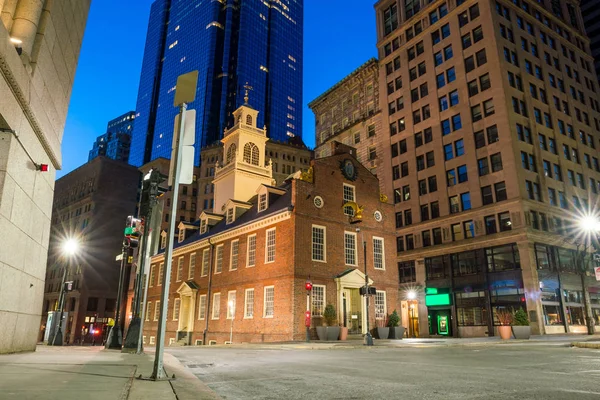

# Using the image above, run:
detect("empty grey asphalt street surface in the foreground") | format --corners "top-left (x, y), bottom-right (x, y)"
top-left (167, 343), bottom-right (600, 400)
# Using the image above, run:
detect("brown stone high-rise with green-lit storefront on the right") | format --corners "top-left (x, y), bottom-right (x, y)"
top-left (375, 0), bottom-right (600, 337)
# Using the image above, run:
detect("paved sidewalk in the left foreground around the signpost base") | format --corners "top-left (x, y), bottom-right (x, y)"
top-left (0, 346), bottom-right (219, 400)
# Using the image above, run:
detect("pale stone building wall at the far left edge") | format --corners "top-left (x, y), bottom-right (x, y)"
top-left (0, 0), bottom-right (91, 353)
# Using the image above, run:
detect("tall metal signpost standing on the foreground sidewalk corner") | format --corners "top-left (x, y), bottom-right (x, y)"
top-left (150, 103), bottom-right (187, 380)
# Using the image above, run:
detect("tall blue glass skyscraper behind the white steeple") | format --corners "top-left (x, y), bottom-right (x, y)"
top-left (129, 0), bottom-right (304, 166)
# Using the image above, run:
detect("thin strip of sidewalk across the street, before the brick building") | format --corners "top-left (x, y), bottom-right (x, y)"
top-left (205, 334), bottom-right (600, 350)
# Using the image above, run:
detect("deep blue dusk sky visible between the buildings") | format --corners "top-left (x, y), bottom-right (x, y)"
top-left (57, 0), bottom-right (377, 178)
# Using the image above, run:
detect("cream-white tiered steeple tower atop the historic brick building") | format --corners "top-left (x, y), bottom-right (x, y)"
top-left (213, 84), bottom-right (273, 213)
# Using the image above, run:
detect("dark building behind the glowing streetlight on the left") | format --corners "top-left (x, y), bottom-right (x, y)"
top-left (39, 156), bottom-right (140, 343)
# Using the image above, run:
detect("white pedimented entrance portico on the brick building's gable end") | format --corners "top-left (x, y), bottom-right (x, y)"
top-left (335, 268), bottom-right (373, 334)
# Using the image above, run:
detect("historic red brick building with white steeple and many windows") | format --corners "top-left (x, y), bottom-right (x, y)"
top-left (144, 102), bottom-right (399, 344)
